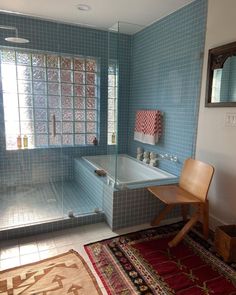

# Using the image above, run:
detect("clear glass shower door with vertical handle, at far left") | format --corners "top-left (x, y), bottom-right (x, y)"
top-left (0, 23), bottom-right (64, 230)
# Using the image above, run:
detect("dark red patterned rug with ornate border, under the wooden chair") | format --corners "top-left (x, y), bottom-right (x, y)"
top-left (85, 223), bottom-right (236, 295)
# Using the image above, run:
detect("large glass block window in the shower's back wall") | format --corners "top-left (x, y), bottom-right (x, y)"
top-left (0, 48), bottom-right (99, 149)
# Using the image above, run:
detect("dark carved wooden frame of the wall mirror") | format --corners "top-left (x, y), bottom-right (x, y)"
top-left (205, 42), bottom-right (236, 107)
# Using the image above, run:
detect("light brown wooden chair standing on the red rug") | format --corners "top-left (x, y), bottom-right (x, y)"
top-left (148, 159), bottom-right (214, 247)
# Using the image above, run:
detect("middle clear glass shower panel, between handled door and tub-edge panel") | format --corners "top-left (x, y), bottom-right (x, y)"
top-left (54, 24), bottom-right (108, 218)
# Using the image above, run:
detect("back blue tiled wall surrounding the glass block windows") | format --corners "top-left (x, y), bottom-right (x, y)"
top-left (0, 13), bottom-right (131, 186)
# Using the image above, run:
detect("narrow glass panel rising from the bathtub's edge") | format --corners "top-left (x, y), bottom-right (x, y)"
top-left (107, 22), bottom-right (143, 189)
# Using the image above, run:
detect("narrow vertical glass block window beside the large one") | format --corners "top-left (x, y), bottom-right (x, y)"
top-left (107, 61), bottom-right (118, 145)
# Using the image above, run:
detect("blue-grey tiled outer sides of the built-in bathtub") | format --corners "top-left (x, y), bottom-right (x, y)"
top-left (78, 159), bottom-right (180, 230)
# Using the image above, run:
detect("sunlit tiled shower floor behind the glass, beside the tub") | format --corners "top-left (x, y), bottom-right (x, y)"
top-left (0, 181), bottom-right (98, 229)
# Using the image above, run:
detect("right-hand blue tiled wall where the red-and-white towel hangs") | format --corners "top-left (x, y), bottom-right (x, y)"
top-left (128, 0), bottom-right (207, 174)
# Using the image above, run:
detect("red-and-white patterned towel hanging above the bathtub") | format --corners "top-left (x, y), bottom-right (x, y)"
top-left (134, 110), bottom-right (162, 145)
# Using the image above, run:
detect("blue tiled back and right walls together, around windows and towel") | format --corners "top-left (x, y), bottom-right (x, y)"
top-left (0, 0), bottom-right (207, 194)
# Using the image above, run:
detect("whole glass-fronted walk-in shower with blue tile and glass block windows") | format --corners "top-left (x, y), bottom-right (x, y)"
top-left (0, 12), bottom-right (137, 236)
